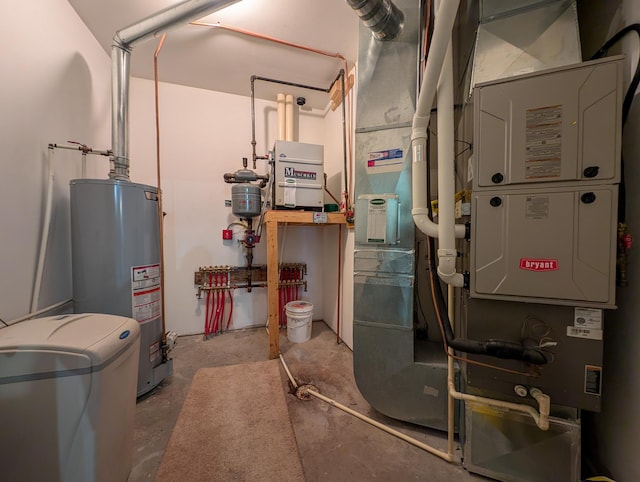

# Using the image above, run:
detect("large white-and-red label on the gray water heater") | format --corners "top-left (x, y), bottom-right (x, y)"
top-left (131, 263), bottom-right (162, 323)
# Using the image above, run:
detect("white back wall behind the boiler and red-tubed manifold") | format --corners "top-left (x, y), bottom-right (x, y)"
top-left (130, 77), bottom-right (351, 334)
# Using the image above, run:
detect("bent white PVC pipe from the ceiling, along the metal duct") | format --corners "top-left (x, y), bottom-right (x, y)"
top-left (411, 0), bottom-right (466, 238)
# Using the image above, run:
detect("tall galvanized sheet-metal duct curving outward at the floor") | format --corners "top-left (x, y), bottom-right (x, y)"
top-left (353, 0), bottom-right (458, 430)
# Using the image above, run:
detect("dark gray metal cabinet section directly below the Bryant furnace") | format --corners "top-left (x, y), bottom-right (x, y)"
top-left (460, 298), bottom-right (606, 411)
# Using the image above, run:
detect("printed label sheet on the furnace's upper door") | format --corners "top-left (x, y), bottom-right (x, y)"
top-left (525, 105), bottom-right (562, 179)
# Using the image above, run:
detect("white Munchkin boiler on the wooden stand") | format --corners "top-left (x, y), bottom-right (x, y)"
top-left (273, 141), bottom-right (324, 211)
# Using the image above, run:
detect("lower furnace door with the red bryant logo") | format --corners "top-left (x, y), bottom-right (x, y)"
top-left (471, 185), bottom-right (618, 308)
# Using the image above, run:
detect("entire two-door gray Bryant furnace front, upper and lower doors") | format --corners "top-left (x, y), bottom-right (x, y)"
top-left (470, 57), bottom-right (622, 308)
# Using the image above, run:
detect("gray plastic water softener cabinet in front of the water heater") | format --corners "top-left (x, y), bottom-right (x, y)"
top-left (0, 314), bottom-right (140, 482)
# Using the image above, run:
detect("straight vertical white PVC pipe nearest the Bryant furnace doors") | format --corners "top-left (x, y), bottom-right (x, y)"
top-left (437, 40), bottom-right (464, 286)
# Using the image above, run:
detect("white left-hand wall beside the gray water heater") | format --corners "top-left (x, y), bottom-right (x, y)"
top-left (0, 0), bottom-right (111, 320)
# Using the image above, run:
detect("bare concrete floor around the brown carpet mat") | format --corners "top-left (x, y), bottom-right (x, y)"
top-left (129, 322), bottom-right (489, 482)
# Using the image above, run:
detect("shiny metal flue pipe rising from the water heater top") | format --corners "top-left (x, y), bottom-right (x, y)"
top-left (109, 0), bottom-right (239, 180)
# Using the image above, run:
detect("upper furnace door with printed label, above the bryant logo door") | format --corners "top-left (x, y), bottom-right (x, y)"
top-left (474, 57), bottom-right (622, 189)
